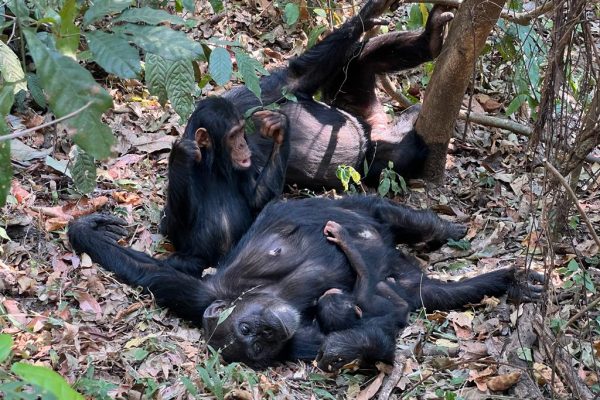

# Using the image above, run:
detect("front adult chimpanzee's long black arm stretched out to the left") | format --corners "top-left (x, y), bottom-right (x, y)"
top-left (68, 214), bottom-right (215, 326)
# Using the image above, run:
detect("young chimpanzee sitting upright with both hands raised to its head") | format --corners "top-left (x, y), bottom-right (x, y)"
top-left (161, 97), bottom-right (289, 275)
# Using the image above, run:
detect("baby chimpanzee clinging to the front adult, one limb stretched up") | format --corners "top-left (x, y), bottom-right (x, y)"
top-left (317, 221), bottom-right (409, 334)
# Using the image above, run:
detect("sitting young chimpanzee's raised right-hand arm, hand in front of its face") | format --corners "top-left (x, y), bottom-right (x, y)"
top-left (250, 111), bottom-right (290, 211)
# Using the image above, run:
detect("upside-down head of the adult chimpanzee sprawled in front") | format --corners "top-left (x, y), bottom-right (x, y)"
top-left (202, 294), bottom-right (300, 367)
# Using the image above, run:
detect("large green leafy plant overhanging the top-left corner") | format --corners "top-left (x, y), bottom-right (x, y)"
top-left (0, 0), bottom-right (266, 205)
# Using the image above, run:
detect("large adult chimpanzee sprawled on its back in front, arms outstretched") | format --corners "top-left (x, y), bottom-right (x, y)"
top-left (69, 197), bottom-right (544, 369)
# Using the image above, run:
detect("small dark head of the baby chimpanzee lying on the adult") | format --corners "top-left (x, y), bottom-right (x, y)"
top-left (317, 288), bottom-right (362, 333)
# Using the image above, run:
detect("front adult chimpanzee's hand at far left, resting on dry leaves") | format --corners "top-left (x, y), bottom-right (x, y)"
top-left (68, 214), bottom-right (127, 252)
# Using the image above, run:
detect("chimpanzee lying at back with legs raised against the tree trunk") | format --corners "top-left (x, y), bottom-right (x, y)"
top-left (223, 0), bottom-right (453, 188)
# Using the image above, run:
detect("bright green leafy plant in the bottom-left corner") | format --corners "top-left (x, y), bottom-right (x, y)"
top-left (0, 334), bottom-right (84, 400)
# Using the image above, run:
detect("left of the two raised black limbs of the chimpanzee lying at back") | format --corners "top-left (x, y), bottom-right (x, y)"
top-left (288, 0), bottom-right (397, 96)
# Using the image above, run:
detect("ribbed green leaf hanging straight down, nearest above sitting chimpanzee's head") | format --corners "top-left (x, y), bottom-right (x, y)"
top-left (166, 60), bottom-right (194, 120)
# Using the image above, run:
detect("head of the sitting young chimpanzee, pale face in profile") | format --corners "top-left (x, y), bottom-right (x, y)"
top-left (184, 97), bottom-right (252, 170)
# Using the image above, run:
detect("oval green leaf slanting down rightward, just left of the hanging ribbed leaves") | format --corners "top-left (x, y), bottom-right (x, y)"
top-left (85, 30), bottom-right (142, 78)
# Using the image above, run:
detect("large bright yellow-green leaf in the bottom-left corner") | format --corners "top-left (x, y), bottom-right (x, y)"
top-left (11, 362), bottom-right (85, 400)
